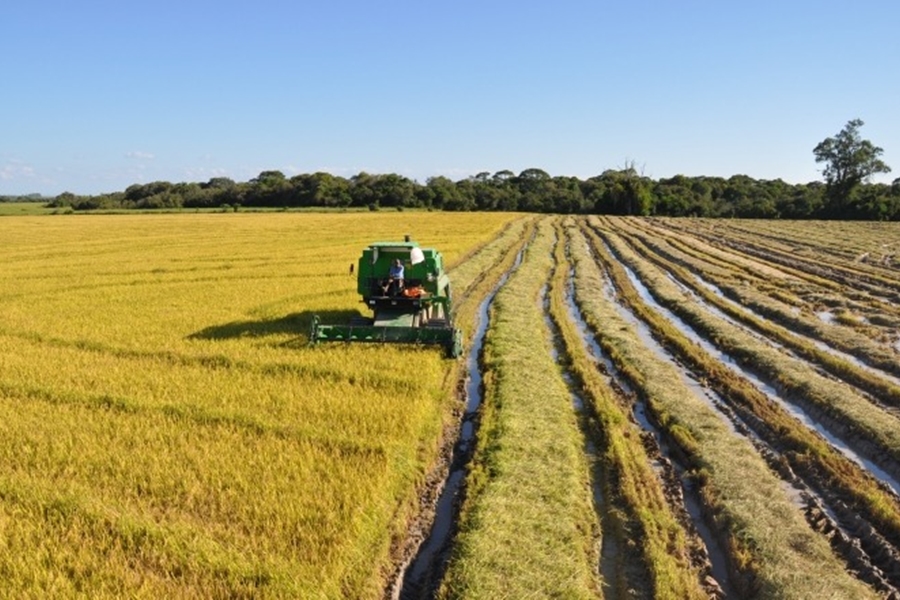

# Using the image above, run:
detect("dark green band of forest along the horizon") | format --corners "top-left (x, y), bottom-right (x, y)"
top-left (26, 167), bottom-right (900, 221)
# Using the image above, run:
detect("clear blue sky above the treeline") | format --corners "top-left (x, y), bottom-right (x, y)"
top-left (0, 0), bottom-right (900, 195)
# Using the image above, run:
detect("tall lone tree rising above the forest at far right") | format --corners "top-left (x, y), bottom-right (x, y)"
top-left (813, 119), bottom-right (891, 217)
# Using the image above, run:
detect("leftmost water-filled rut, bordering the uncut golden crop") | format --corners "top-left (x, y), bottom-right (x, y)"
top-left (391, 244), bottom-right (528, 600)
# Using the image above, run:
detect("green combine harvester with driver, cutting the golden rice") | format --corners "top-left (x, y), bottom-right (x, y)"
top-left (309, 236), bottom-right (462, 358)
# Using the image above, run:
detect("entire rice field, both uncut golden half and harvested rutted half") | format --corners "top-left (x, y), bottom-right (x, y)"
top-left (0, 213), bottom-right (900, 599)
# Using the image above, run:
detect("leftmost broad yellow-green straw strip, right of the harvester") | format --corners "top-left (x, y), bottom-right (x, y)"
top-left (441, 219), bottom-right (599, 599)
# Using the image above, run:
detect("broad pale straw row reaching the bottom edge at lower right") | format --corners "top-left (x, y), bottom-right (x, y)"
top-left (576, 221), bottom-right (880, 597)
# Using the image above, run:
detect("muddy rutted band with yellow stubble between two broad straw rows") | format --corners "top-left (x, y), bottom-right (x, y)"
top-left (545, 226), bottom-right (733, 598)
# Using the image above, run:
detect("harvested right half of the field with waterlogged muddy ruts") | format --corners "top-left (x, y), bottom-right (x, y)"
top-left (440, 218), bottom-right (900, 598)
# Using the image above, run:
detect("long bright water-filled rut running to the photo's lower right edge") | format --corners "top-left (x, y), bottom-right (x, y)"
top-left (607, 247), bottom-right (900, 494)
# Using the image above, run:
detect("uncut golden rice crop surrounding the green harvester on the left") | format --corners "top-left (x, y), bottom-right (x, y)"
top-left (0, 213), bottom-right (513, 597)
